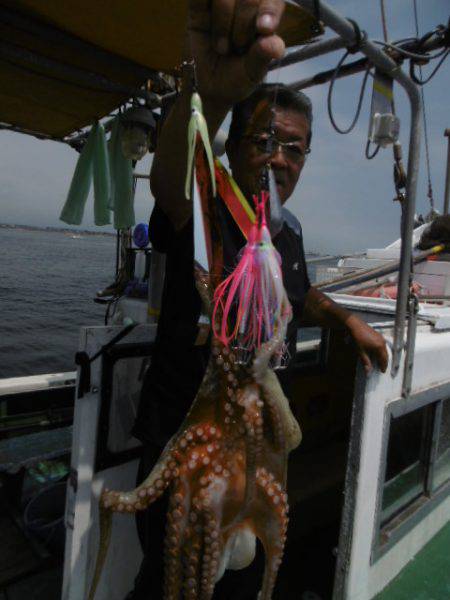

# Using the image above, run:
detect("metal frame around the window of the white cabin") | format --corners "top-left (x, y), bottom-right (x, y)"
top-left (370, 382), bottom-right (450, 565)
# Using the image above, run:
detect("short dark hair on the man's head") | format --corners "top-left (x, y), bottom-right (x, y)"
top-left (228, 83), bottom-right (313, 147)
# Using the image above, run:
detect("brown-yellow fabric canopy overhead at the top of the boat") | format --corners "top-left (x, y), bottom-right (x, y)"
top-left (0, 0), bottom-right (321, 139)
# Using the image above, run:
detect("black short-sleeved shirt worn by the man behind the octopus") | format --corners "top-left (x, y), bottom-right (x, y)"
top-left (133, 200), bottom-right (310, 446)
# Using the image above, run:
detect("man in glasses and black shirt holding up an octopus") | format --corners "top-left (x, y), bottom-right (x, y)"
top-left (131, 0), bottom-right (387, 600)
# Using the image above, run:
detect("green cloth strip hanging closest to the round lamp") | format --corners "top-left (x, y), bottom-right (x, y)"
top-left (108, 116), bottom-right (136, 229)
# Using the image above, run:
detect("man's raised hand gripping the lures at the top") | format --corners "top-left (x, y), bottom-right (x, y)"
top-left (187, 0), bottom-right (284, 110)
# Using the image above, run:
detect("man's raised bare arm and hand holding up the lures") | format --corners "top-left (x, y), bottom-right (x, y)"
top-left (150, 0), bottom-right (284, 230)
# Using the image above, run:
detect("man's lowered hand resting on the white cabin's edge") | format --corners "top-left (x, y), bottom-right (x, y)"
top-left (345, 315), bottom-right (388, 374)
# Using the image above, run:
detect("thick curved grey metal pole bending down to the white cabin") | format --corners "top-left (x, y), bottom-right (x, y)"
top-left (294, 0), bottom-right (421, 376)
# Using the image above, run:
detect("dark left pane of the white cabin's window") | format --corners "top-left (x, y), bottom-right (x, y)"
top-left (381, 406), bottom-right (430, 526)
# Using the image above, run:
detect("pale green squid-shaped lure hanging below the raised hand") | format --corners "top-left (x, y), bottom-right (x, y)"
top-left (184, 92), bottom-right (216, 200)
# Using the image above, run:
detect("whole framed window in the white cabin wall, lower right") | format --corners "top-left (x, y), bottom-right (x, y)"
top-left (372, 382), bottom-right (450, 561)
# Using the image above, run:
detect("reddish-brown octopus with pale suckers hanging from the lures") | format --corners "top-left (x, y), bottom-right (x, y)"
top-left (89, 152), bottom-right (301, 600)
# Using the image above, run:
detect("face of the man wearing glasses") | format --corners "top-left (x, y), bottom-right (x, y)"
top-left (227, 106), bottom-right (309, 204)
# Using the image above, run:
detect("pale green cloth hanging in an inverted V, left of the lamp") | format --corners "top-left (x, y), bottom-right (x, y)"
top-left (59, 123), bottom-right (111, 225)
